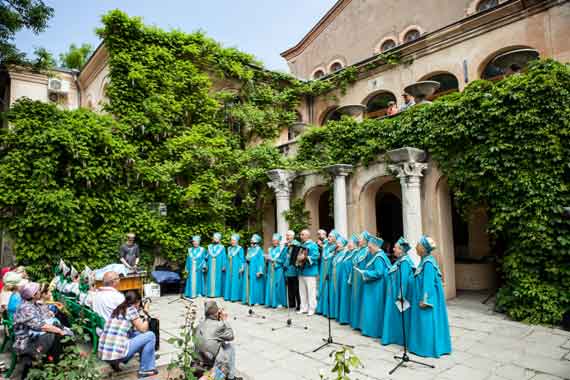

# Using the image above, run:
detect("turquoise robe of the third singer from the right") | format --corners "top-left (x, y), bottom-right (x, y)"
top-left (360, 250), bottom-right (392, 338)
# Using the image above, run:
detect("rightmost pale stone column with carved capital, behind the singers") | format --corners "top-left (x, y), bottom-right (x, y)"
top-left (388, 148), bottom-right (427, 246)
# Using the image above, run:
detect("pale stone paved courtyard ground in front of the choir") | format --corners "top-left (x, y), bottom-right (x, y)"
top-left (152, 293), bottom-right (570, 380)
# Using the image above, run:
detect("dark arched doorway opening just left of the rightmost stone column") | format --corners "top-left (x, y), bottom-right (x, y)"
top-left (376, 191), bottom-right (404, 255)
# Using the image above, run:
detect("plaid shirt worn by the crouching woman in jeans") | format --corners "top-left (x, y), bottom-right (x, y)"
top-left (99, 306), bottom-right (139, 361)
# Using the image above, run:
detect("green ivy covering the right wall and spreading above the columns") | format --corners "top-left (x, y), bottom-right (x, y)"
top-left (290, 60), bottom-right (570, 323)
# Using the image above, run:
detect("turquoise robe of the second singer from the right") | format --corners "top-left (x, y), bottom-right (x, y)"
top-left (382, 255), bottom-right (414, 346)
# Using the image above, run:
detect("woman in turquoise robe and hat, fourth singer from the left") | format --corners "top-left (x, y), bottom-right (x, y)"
top-left (242, 234), bottom-right (265, 305)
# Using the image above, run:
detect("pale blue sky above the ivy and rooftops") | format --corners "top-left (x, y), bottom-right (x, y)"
top-left (16, 0), bottom-right (335, 71)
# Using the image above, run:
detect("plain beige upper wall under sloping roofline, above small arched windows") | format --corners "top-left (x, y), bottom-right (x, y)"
top-left (288, 0), bottom-right (472, 79)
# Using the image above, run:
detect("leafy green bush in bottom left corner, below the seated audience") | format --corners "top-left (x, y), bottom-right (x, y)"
top-left (27, 326), bottom-right (103, 380)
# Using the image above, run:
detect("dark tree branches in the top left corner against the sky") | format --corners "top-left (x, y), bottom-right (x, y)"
top-left (0, 0), bottom-right (54, 64)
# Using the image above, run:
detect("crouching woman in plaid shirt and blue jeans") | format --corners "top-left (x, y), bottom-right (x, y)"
top-left (99, 290), bottom-right (158, 378)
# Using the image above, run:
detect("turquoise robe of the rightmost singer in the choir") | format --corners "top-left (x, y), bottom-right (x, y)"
top-left (408, 255), bottom-right (451, 358)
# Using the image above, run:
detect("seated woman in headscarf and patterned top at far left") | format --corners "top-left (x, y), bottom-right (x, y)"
top-left (14, 282), bottom-right (72, 379)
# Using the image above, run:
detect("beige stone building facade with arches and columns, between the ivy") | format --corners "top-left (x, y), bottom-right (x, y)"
top-left (0, 0), bottom-right (570, 297)
